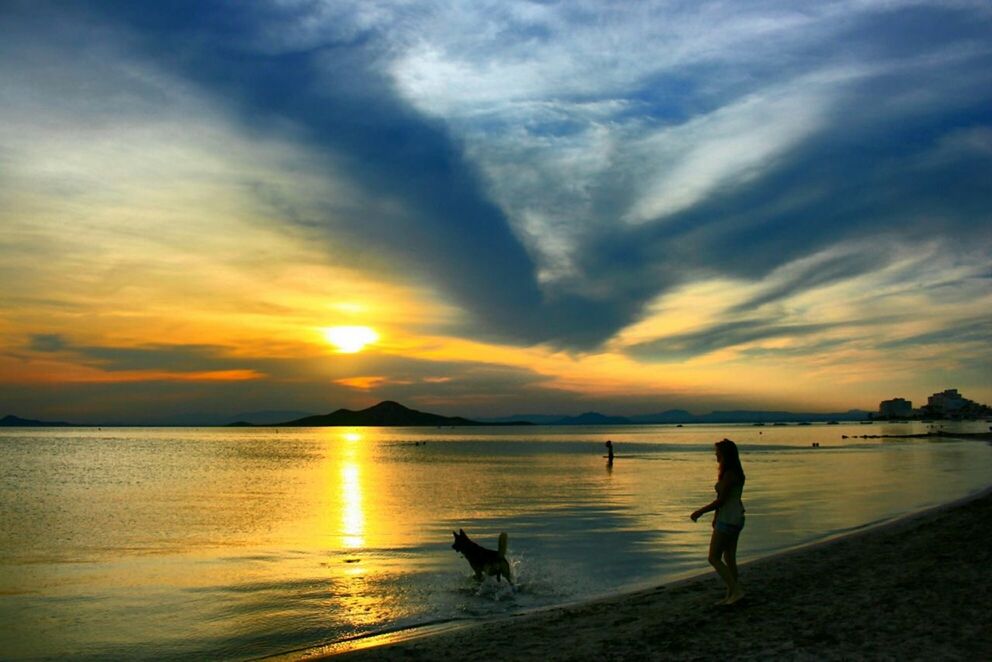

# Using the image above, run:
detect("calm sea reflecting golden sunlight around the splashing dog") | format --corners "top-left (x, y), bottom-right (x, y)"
top-left (0, 423), bottom-right (992, 659)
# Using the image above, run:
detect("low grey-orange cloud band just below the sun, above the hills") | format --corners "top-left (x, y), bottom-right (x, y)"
top-left (11, 334), bottom-right (576, 423)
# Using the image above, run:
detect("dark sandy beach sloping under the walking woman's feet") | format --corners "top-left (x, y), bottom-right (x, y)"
top-left (302, 492), bottom-right (992, 662)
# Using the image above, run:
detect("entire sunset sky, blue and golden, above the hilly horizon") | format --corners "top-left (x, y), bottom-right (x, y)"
top-left (0, 0), bottom-right (992, 423)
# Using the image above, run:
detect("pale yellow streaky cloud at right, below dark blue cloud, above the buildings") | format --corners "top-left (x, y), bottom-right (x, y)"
top-left (616, 236), bottom-right (992, 369)
